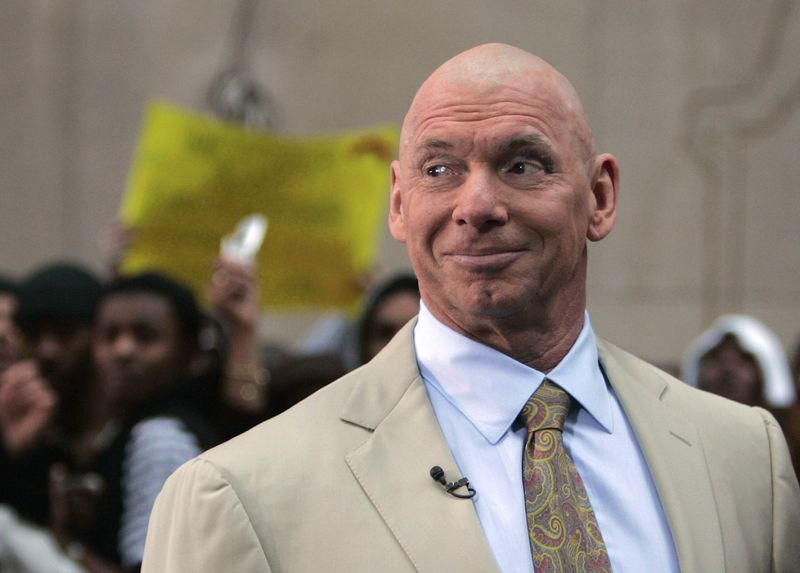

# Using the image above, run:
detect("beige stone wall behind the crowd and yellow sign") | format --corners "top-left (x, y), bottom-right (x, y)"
top-left (0, 0), bottom-right (800, 362)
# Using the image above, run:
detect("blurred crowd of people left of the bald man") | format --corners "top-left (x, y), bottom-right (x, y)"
top-left (0, 259), bottom-right (419, 572)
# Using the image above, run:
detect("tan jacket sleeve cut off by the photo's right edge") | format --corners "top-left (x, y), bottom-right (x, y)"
top-left (761, 410), bottom-right (800, 573)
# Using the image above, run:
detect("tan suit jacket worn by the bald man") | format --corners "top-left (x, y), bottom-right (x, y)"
top-left (143, 321), bottom-right (800, 573)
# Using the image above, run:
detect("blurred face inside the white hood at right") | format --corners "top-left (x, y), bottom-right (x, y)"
top-left (698, 335), bottom-right (762, 406)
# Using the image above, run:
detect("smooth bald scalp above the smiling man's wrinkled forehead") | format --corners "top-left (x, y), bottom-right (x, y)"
top-left (400, 44), bottom-right (594, 158)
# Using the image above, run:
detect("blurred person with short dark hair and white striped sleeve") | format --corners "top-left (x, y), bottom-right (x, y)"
top-left (52, 273), bottom-right (217, 571)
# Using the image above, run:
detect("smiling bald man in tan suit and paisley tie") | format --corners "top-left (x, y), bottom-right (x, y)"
top-left (144, 44), bottom-right (800, 573)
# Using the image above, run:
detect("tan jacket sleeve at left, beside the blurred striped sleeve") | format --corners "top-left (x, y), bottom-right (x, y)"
top-left (142, 458), bottom-right (270, 573)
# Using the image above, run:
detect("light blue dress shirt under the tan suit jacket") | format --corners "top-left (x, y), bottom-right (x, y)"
top-left (414, 303), bottom-right (680, 573)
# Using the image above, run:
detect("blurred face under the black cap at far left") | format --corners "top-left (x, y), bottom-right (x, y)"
top-left (22, 319), bottom-right (92, 397)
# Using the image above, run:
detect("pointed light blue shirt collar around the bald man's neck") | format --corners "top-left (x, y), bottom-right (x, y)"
top-left (414, 302), bottom-right (613, 444)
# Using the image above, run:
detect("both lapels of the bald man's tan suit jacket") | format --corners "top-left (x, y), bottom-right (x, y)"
top-left (341, 321), bottom-right (725, 573)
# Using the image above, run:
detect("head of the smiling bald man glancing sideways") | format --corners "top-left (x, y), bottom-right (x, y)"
top-left (389, 44), bottom-right (618, 346)
